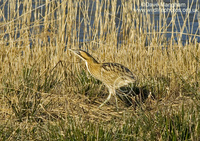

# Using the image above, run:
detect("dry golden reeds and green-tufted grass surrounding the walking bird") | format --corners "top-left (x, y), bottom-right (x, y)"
top-left (0, 0), bottom-right (200, 140)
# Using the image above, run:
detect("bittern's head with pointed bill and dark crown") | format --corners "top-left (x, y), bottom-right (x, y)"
top-left (69, 49), bottom-right (98, 63)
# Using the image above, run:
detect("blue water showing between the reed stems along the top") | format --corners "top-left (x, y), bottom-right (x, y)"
top-left (0, 0), bottom-right (200, 45)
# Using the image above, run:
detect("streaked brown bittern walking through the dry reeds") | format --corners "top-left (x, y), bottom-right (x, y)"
top-left (69, 49), bottom-right (136, 109)
